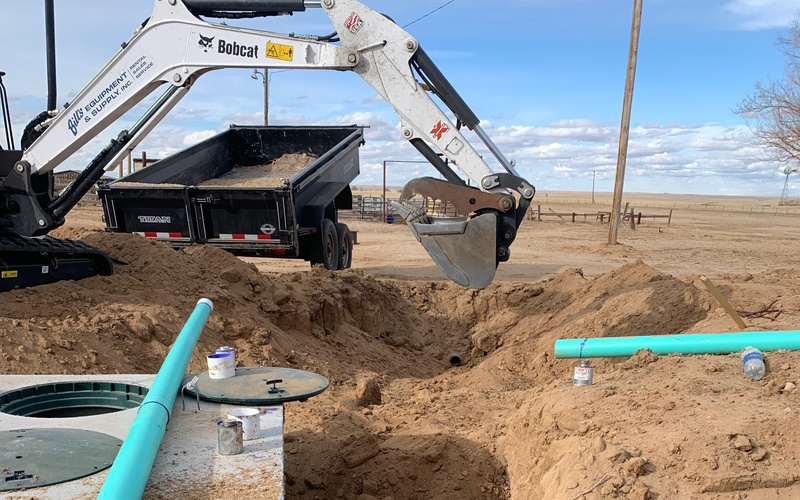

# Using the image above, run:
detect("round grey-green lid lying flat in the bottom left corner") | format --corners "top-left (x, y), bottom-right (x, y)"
top-left (0, 428), bottom-right (122, 491)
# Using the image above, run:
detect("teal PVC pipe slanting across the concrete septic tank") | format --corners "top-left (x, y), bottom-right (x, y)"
top-left (97, 299), bottom-right (214, 500)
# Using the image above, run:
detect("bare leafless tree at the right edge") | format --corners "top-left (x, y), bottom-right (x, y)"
top-left (734, 15), bottom-right (800, 165)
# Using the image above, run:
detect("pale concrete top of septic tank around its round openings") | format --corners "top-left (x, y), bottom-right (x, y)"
top-left (0, 374), bottom-right (285, 500)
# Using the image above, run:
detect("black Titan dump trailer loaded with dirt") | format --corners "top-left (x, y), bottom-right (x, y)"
top-left (98, 126), bottom-right (364, 270)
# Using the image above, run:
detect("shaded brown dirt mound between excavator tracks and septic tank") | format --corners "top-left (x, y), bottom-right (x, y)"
top-left (0, 232), bottom-right (467, 380)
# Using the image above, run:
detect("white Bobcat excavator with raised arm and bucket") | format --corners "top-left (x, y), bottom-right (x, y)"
top-left (0, 0), bottom-right (535, 291)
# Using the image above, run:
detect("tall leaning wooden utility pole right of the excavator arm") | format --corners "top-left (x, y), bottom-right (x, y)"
top-left (608, 0), bottom-right (642, 245)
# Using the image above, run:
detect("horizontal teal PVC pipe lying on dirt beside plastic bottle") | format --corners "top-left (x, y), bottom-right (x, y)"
top-left (555, 330), bottom-right (800, 358)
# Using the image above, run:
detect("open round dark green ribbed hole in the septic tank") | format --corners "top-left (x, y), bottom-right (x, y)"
top-left (0, 380), bottom-right (147, 418)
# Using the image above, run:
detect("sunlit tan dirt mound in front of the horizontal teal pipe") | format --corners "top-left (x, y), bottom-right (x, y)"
top-left (503, 353), bottom-right (800, 499)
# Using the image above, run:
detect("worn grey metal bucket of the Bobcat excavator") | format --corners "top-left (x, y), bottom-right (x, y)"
top-left (393, 201), bottom-right (497, 289)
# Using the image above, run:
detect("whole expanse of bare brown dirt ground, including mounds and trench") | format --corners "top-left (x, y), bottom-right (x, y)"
top-left (0, 199), bottom-right (800, 500)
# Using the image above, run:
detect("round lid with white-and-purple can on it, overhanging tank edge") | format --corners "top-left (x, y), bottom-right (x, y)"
top-left (181, 366), bottom-right (329, 406)
